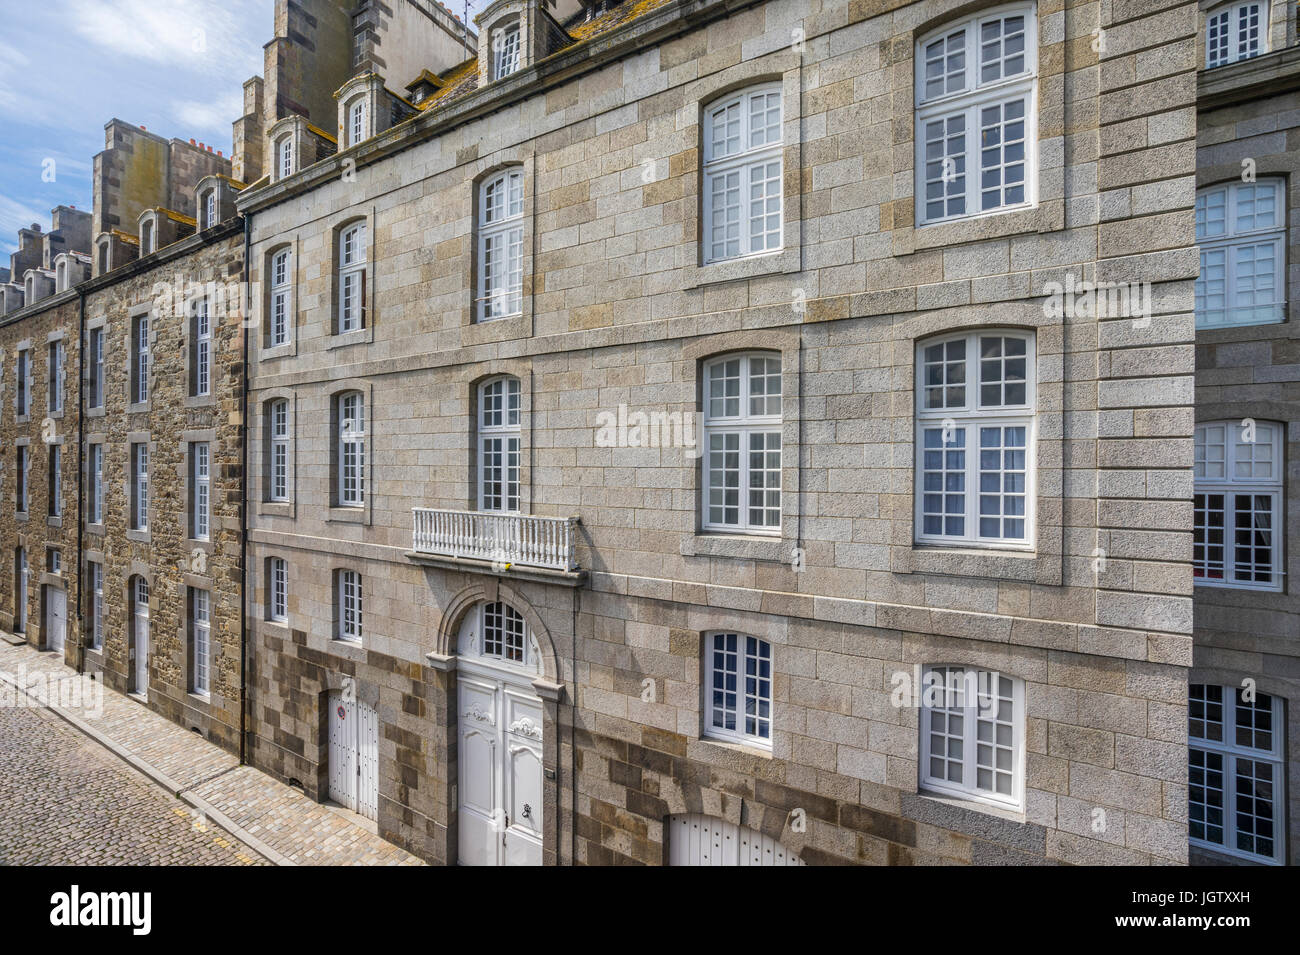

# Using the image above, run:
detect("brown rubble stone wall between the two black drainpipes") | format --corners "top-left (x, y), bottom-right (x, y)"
top-left (86, 223), bottom-right (243, 752)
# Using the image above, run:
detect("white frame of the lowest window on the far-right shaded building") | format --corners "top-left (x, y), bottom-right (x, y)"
top-left (1187, 683), bottom-right (1287, 865)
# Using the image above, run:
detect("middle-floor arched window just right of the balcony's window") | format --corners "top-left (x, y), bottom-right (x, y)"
top-left (701, 352), bottom-right (781, 534)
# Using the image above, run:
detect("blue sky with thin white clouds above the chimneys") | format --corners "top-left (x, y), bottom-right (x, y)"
top-left (0, 0), bottom-right (499, 256)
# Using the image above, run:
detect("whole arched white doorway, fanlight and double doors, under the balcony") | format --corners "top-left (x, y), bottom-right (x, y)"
top-left (456, 600), bottom-right (543, 865)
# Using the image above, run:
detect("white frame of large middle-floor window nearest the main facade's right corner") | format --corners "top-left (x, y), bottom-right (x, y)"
top-left (913, 329), bottom-right (1037, 551)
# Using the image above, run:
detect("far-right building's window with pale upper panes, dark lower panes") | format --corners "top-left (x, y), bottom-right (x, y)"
top-left (1192, 418), bottom-right (1286, 590)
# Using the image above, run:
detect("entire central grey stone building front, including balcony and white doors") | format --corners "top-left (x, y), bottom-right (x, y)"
top-left (239, 0), bottom-right (1197, 864)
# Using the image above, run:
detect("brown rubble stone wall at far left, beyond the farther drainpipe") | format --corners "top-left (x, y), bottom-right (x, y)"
top-left (0, 295), bottom-right (79, 664)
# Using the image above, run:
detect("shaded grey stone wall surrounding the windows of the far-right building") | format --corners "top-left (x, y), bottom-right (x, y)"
top-left (1191, 70), bottom-right (1300, 864)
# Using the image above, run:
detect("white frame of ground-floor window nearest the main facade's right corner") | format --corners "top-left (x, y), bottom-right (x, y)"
top-left (918, 664), bottom-right (1026, 811)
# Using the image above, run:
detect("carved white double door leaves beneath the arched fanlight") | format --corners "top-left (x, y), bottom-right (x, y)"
top-left (456, 665), bottom-right (542, 865)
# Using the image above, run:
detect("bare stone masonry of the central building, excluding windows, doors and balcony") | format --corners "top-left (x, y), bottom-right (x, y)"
top-left (246, 0), bottom-right (1196, 863)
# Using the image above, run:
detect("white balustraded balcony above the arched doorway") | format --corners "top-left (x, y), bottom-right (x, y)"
top-left (412, 508), bottom-right (579, 573)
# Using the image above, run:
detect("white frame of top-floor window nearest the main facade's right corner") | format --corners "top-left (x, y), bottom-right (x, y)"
top-left (914, 3), bottom-right (1039, 225)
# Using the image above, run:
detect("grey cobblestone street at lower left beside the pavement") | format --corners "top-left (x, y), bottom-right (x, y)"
top-left (0, 707), bottom-right (267, 865)
